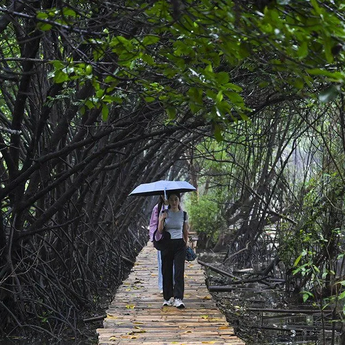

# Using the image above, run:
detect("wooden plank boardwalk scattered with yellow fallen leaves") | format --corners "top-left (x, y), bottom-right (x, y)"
top-left (97, 243), bottom-right (245, 345)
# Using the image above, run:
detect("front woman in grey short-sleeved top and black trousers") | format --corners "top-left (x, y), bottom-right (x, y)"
top-left (158, 192), bottom-right (188, 308)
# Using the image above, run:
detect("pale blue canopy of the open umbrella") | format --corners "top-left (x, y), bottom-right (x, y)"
top-left (129, 180), bottom-right (196, 196)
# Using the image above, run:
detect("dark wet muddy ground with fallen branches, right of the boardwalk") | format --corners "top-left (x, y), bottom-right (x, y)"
top-left (198, 250), bottom-right (343, 345)
